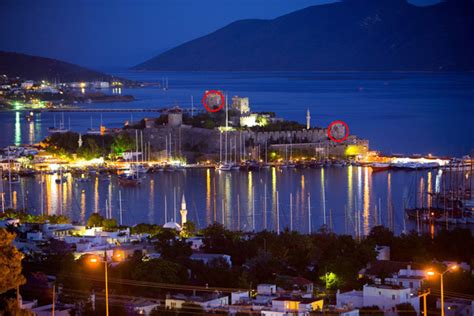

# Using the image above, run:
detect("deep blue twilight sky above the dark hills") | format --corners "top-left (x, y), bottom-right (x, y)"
top-left (0, 0), bottom-right (438, 67)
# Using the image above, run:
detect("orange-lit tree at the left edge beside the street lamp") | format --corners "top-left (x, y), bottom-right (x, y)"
top-left (0, 228), bottom-right (25, 294)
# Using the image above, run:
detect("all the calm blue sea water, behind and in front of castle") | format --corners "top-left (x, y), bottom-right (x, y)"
top-left (0, 71), bottom-right (474, 234)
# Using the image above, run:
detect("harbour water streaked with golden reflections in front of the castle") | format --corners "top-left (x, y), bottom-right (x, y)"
top-left (3, 167), bottom-right (468, 235)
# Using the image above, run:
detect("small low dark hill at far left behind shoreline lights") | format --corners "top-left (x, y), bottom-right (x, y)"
top-left (0, 51), bottom-right (112, 82)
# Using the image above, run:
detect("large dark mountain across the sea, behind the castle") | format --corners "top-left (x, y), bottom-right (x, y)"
top-left (133, 0), bottom-right (474, 71)
